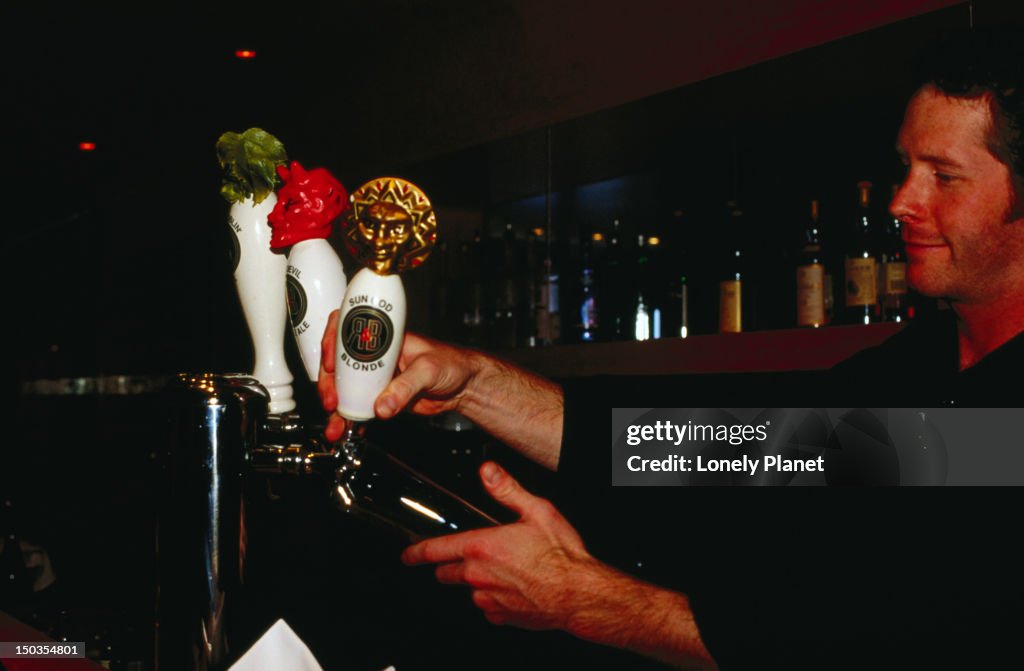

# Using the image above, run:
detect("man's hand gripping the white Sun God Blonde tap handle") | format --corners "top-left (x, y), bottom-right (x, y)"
top-left (316, 310), bottom-right (477, 441)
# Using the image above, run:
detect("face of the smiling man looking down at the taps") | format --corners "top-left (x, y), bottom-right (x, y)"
top-left (890, 86), bottom-right (1024, 303)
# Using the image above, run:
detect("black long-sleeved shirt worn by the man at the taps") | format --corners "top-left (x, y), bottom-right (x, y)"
top-left (557, 313), bottom-right (1024, 671)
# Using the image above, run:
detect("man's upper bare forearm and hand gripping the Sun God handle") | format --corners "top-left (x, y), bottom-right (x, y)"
top-left (317, 310), bottom-right (563, 470)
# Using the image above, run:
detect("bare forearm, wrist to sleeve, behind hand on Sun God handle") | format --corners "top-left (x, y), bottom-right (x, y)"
top-left (459, 352), bottom-right (564, 470)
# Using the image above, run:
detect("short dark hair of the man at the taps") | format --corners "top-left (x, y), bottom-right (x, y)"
top-left (916, 28), bottom-right (1024, 185)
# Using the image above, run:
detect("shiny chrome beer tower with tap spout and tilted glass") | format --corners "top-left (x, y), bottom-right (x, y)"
top-left (157, 373), bottom-right (497, 671)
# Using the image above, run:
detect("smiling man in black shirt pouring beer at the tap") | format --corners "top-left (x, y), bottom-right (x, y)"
top-left (318, 32), bottom-right (1024, 669)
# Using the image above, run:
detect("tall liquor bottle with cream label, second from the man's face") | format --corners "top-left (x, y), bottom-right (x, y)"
top-left (846, 181), bottom-right (879, 324)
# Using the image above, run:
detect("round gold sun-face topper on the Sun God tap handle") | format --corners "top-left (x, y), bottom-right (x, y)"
top-left (344, 177), bottom-right (437, 275)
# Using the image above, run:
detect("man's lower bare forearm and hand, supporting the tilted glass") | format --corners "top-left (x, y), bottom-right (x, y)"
top-left (402, 462), bottom-right (716, 669)
